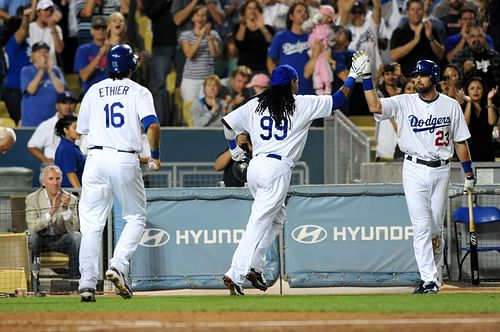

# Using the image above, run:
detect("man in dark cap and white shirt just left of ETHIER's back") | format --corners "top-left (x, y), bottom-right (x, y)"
top-left (28, 90), bottom-right (77, 165)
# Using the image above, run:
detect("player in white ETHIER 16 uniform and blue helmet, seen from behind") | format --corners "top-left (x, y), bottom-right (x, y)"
top-left (76, 44), bottom-right (160, 302)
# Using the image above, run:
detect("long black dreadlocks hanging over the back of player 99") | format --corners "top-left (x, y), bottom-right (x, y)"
top-left (255, 83), bottom-right (295, 128)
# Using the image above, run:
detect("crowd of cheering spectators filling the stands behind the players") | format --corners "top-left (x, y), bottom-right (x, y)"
top-left (0, 0), bottom-right (500, 163)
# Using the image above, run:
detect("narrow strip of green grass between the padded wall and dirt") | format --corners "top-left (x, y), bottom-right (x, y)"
top-left (0, 292), bottom-right (500, 314)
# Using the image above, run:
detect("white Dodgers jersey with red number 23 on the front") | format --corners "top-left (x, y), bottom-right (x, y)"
top-left (375, 93), bottom-right (470, 160)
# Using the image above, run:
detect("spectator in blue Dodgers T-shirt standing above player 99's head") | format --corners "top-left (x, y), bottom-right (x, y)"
top-left (267, 2), bottom-right (314, 95)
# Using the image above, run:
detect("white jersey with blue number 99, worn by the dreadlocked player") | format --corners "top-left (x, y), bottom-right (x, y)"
top-left (223, 95), bottom-right (333, 163)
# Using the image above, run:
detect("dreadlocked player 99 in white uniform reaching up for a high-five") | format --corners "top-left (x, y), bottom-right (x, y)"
top-left (222, 53), bottom-right (367, 295)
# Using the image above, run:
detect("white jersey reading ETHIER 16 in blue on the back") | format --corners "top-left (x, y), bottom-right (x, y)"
top-left (76, 78), bottom-right (156, 151)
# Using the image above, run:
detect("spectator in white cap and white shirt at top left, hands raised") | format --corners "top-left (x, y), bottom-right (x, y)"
top-left (28, 0), bottom-right (64, 64)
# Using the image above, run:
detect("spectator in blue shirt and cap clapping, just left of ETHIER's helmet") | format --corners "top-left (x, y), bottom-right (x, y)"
top-left (75, 16), bottom-right (111, 94)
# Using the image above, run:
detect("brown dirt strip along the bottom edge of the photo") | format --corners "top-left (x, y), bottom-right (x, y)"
top-left (0, 312), bottom-right (500, 332)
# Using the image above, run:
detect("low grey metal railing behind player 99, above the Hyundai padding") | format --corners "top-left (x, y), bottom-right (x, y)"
top-left (143, 161), bottom-right (309, 188)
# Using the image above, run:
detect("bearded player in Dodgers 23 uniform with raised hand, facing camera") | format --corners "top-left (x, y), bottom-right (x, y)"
top-left (361, 53), bottom-right (475, 294)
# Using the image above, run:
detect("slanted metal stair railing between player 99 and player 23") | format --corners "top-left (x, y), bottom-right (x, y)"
top-left (324, 111), bottom-right (370, 184)
